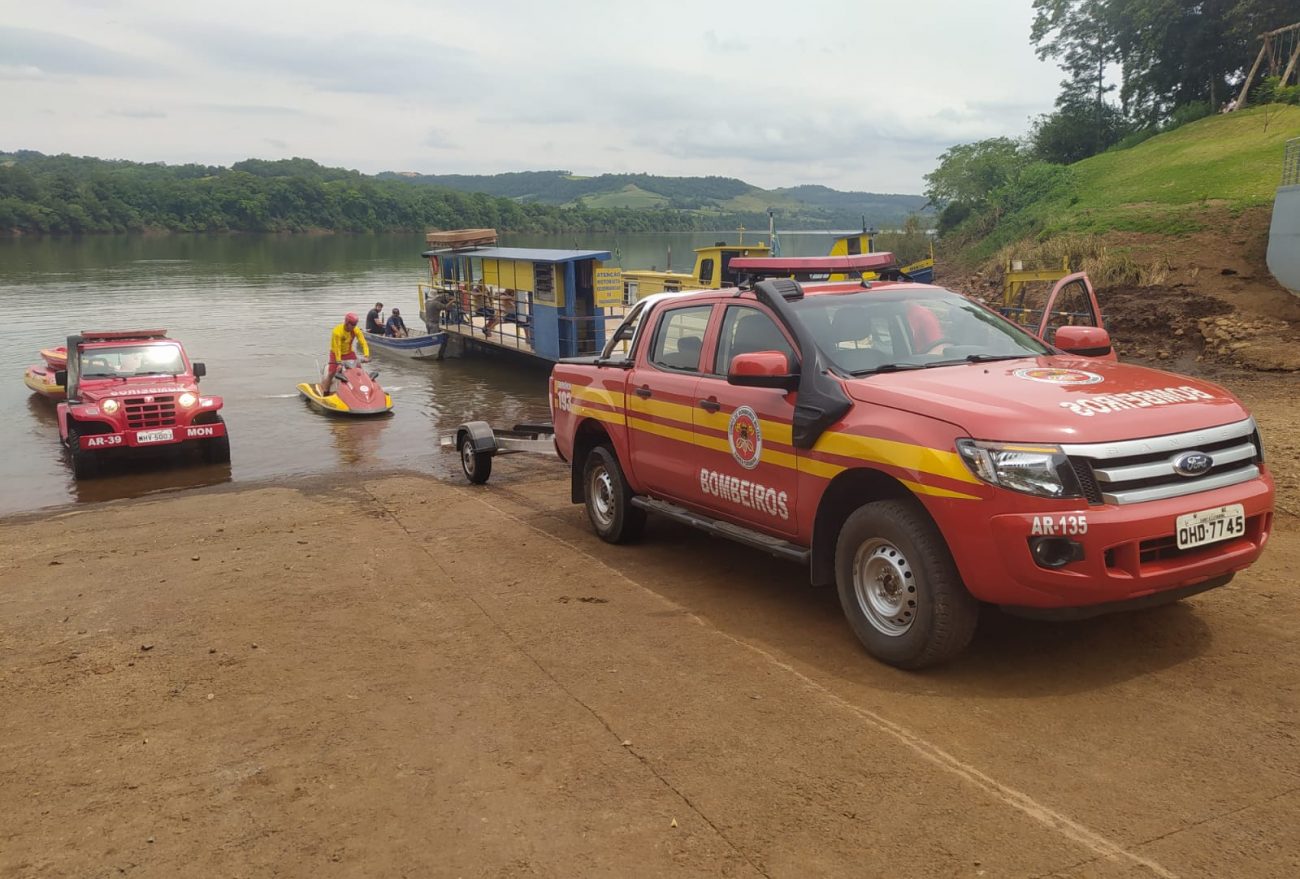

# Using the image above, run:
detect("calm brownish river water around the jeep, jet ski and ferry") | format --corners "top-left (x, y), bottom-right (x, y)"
top-left (0, 233), bottom-right (832, 515)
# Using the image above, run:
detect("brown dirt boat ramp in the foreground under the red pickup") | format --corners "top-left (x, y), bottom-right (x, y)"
top-left (0, 458), bottom-right (1300, 878)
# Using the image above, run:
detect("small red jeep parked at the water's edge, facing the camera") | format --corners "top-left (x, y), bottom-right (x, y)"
top-left (57, 330), bottom-right (230, 479)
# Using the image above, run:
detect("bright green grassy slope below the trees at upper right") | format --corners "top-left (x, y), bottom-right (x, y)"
top-left (1040, 105), bottom-right (1300, 234)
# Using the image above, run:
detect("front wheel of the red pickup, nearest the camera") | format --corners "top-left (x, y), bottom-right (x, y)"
top-left (835, 501), bottom-right (979, 668)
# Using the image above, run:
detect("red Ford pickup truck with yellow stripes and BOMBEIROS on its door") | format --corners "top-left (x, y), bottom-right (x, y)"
top-left (550, 255), bottom-right (1274, 668)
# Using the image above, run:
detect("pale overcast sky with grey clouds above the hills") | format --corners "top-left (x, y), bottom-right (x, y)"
top-left (0, 0), bottom-right (1061, 192)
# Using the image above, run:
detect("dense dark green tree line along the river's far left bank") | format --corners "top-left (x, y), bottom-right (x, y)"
top-left (0, 151), bottom-right (767, 234)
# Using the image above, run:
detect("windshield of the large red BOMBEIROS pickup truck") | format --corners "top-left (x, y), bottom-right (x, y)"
top-left (790, 290), bottom-right (1052, 376)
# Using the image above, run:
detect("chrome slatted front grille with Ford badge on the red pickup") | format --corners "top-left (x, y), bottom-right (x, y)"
top-left (1062, 419), bottom-right (1264, 503)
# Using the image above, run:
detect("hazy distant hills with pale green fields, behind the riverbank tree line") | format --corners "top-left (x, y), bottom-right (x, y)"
top-left (378, 170), bottom-right (926, 229)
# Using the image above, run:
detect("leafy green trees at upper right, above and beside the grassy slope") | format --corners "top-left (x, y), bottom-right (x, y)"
top-left (926, 0), bottom-right (1300, 239)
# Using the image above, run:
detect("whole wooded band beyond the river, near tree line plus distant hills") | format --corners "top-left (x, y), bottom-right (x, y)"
top-left (0, 151), bottom-right (924, 234)
